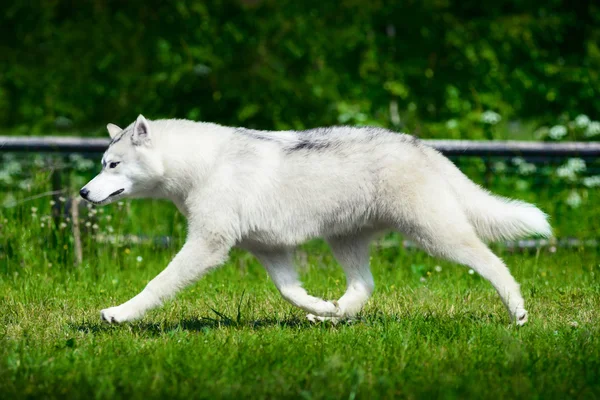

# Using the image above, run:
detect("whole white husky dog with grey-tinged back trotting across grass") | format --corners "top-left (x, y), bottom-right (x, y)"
top-left (80, 115), bottom-right (551, 325)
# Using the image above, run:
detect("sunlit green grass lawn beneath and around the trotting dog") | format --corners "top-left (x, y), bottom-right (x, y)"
top-left (0, 168), bottom-right (600, 399)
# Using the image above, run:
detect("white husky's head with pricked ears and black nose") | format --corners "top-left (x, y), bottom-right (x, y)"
top-left (79, 115), bottom-right (164, 205)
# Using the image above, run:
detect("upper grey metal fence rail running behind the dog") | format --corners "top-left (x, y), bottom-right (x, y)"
top-left (0, 136), bottom-right (600, 158)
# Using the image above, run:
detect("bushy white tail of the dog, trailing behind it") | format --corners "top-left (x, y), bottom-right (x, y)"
top-left (428, 149), bottom-right (552, 241)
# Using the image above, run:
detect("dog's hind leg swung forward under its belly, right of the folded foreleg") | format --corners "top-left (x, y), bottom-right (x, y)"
top-left (307, 235), bottom-right (375, 322)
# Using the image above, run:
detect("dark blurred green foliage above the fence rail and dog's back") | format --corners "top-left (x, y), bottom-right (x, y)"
top-left (0, 0), bottom-right (600, 138)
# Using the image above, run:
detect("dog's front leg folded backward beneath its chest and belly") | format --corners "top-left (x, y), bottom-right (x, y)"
top-left (254, 250), bottom-right (341, 317)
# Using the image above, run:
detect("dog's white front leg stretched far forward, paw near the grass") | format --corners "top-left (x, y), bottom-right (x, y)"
top-left (101, 236), bottom-right (231, 323)
